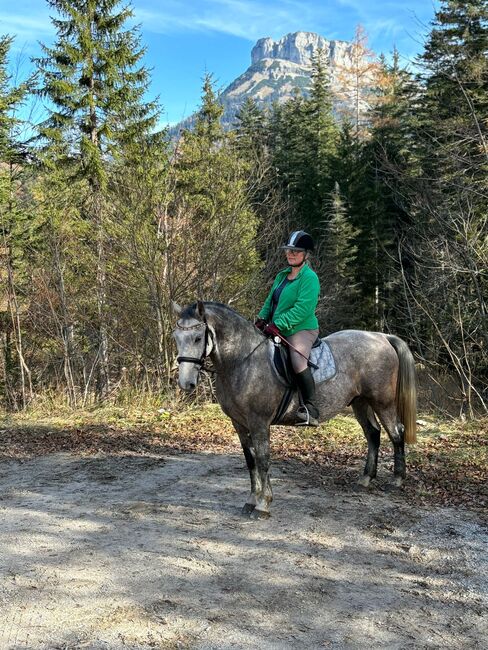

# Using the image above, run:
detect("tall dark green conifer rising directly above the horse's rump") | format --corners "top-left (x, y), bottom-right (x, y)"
top-left (362, 50), bottom-right (419, 335)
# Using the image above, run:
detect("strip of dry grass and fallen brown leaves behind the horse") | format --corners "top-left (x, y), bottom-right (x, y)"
top-left (0, 399), bottom-right (488, 510)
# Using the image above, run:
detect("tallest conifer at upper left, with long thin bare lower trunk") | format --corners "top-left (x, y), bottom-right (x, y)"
top-left (37, 0), bottom-right (157, 398)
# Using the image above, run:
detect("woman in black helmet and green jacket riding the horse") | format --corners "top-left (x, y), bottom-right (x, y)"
top-left (255, 230), bottom-right (320, 426)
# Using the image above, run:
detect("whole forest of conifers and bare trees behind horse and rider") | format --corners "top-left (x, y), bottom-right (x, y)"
top-left (0, 0), bottom-right (488, 419)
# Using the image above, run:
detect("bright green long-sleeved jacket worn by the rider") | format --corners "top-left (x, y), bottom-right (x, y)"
top-left (258, 264), bottom-right (320, 336)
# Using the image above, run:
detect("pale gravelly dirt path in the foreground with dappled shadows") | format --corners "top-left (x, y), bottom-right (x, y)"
top-left (0, 453), bottom-right (488, 650)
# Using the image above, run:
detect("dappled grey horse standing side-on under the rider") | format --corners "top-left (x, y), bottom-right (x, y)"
top-left (173, 301), bottom-right (416, 519)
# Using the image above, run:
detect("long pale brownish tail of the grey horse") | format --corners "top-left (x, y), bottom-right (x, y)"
top-left (386, 335), bottom-right (417, 444)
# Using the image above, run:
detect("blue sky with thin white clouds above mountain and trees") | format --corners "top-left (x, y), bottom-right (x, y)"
top-left (0, 0), bottom-right (439, 123)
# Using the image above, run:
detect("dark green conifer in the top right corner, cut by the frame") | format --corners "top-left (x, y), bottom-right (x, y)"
top-left (419, 0), bottom-right (488, 191)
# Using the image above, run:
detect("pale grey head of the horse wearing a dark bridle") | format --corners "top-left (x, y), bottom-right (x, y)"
top-left (173, 300), bottom-right (213, 391)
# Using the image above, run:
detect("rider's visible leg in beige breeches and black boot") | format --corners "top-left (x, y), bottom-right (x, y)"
top-left (287, 330), bottom-right (319, 426)
